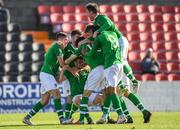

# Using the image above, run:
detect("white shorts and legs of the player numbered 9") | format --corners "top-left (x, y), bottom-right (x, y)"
top-left (99, 64), bottom-right (126, 123)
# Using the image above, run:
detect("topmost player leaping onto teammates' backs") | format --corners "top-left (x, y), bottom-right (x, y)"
top-left (86, 3), bottom-right (140, 91)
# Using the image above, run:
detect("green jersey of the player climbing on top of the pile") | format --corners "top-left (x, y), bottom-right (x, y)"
top-left (94, 14), bottom-right (122, 39)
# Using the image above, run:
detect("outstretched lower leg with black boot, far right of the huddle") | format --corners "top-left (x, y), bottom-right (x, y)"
top-left (124, 91), bottom-right (152, 123)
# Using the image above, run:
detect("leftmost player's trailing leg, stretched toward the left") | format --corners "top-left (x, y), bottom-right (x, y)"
top-left (23, 92), bottom-right (50, 125)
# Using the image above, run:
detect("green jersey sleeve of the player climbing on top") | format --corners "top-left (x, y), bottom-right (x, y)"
top-left (94, 16), bottom-right (112, 33)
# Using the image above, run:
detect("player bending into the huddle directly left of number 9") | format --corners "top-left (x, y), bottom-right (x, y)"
top-left (65, 35), bottom-right (104, 124)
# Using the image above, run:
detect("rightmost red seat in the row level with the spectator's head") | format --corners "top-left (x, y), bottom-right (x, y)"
top-left (166, 51), bottom-right (179, 62)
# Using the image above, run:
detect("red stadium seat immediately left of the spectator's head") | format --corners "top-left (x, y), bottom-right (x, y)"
top-left (128, 51), bottom-right (141, 62)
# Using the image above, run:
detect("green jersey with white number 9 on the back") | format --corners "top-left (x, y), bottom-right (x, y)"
top-left (87, 31), bottom-right (121, 68)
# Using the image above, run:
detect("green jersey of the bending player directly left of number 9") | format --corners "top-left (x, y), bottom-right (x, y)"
top-left (75, 43), bottom-right (104, 70)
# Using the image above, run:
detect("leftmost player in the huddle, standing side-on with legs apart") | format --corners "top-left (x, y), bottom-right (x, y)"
top-left (23, 32), bottom-right (68, 125)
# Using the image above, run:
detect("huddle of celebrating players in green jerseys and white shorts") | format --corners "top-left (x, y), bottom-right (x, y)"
top-left (23, 3), bottom-right (152, 125)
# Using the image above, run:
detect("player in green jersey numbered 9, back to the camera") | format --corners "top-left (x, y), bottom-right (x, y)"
top-left (87, 25), bottom-right (126, 124)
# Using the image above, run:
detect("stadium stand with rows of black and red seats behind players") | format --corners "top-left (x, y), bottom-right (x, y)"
top-left (0, 4), bottom-right (180, 82)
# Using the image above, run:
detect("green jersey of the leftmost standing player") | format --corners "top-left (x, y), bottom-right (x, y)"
top-left (41, 43), bottom-right (63, 76)
